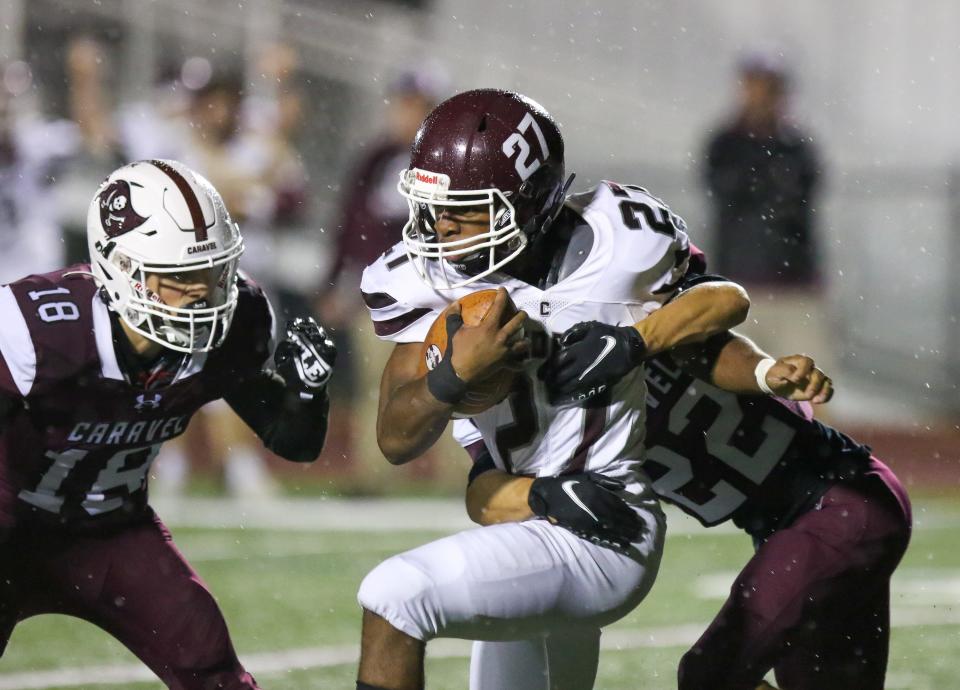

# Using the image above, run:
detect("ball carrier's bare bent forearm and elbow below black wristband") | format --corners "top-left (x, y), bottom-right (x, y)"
top-left (377, 377), bottom-right (453, 465)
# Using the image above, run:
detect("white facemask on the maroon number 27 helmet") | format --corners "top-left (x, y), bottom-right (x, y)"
top-left (397, 168), bottom-right (527, 290)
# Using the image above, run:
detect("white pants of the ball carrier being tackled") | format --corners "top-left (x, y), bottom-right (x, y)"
top-left (357, 500), bottom-right (666, 690)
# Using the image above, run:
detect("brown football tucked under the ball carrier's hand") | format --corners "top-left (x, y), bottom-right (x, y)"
top-left (419, 290), bottom-right (517, 417)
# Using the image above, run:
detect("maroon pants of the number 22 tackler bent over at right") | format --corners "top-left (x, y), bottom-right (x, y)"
top-left (679, 460), bottom-right (911, 690)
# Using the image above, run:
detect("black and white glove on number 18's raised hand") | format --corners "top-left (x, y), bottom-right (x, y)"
top-left (273, 318), bottom-right (337, 399)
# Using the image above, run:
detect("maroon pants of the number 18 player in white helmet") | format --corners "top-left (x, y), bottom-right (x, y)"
top-left (0, 508), bottom-right (257, 690)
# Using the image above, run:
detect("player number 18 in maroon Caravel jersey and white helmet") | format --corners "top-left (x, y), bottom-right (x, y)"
top-left (0, 160), bottom-right (336, 690)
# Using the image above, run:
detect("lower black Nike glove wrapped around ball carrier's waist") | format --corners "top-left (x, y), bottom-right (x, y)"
top-left (527, 472), bottom-right (643, 550)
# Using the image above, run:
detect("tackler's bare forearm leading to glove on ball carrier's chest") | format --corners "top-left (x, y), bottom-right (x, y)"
top-left (635, 282), bottom-right (750, 355)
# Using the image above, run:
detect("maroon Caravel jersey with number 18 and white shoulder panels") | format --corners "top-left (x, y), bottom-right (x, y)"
top-left (0, 265), bottom-right (273, 528)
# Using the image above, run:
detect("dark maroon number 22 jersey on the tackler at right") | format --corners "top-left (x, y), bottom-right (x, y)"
top-left (644, 356), bottom-right (870, 536)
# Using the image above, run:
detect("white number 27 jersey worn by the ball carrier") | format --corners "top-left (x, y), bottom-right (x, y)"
top-left (361, 182), bottom-right (689, 476)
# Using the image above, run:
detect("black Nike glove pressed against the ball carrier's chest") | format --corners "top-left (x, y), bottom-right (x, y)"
top-left (540, 321), bottom-right (647, 405)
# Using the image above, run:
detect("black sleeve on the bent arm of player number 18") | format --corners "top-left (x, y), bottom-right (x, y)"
top-left (223, 370), bottom-right (330, 462)
